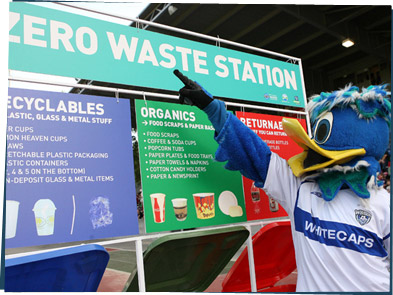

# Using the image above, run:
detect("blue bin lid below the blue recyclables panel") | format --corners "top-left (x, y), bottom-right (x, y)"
top-left (4, 245), bottom-right (109, 292)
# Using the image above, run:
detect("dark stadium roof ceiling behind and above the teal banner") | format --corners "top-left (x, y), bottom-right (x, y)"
top-left (72, 3), bottom-right (392, 105)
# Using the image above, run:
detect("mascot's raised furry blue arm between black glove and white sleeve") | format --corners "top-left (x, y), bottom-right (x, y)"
top-left (215, 112), bottom-right (271, 187)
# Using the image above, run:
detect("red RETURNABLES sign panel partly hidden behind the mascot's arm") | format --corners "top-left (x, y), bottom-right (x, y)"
top-left (236, 112), bottom-right (306, 220)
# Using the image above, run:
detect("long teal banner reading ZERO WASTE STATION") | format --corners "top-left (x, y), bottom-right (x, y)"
top-left (9, 2), bottom-right (304, 107)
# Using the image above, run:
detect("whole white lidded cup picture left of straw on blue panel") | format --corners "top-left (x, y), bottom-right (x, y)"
top-left (33, 199), bottom-right (56, 236)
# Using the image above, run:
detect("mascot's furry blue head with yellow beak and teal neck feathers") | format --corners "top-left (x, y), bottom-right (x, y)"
top-left (283, 85), bottom-right (391, 200)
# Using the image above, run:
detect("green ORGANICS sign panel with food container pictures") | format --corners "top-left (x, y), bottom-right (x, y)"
top-left (135, 100), bottom-right (247, 232)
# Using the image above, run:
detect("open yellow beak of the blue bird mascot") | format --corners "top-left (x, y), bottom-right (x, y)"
top-left (282, 118), bottom-right (366, 176)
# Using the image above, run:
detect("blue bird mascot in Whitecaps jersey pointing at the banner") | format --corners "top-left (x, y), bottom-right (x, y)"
top-left (175, 70), bottom-right (391, 292)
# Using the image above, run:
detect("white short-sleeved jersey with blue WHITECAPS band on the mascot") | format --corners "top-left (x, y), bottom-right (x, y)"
top-left (263, 153), bottom-right (390, 292)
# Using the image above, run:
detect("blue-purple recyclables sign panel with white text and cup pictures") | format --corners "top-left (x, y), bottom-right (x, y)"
top-left (5, 88), bottom-right (139, 248)
